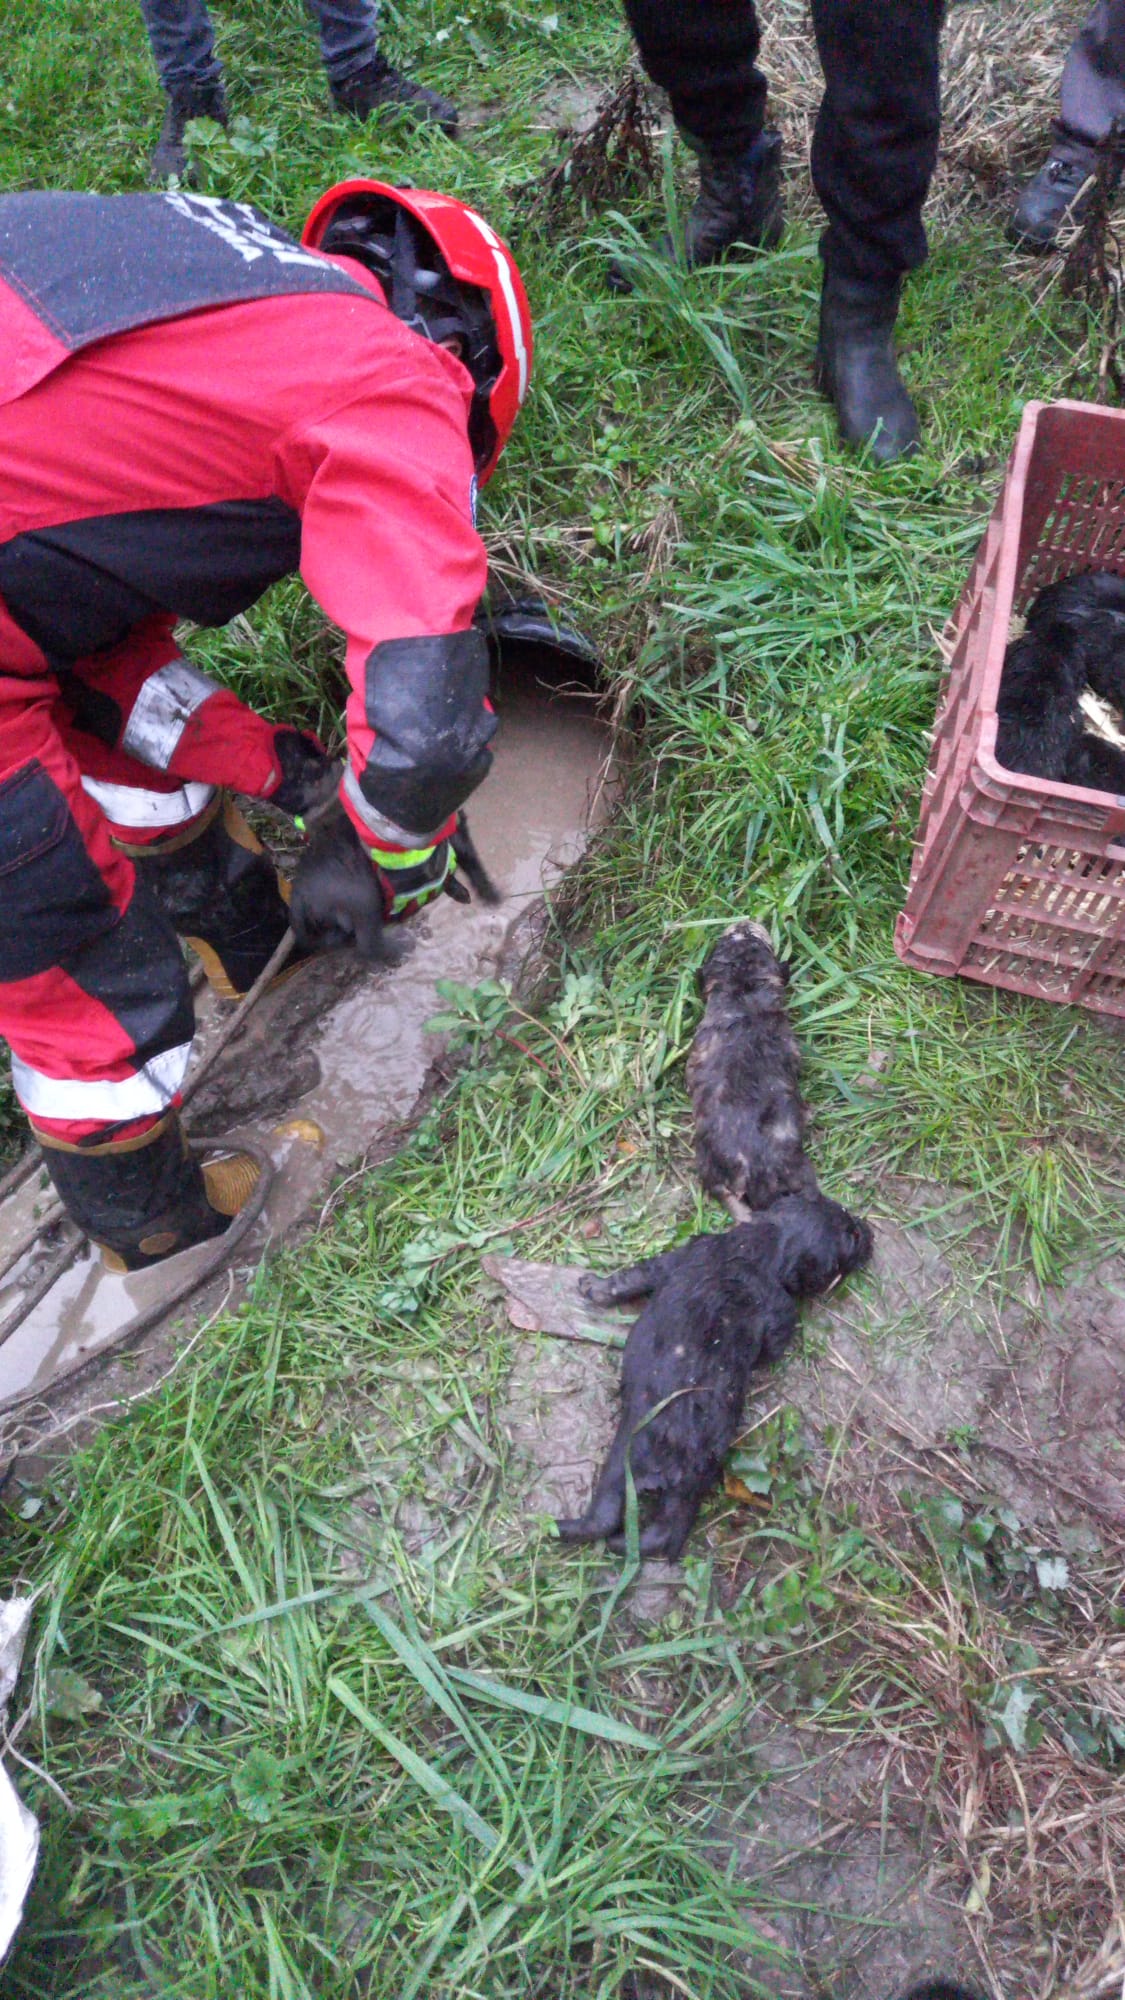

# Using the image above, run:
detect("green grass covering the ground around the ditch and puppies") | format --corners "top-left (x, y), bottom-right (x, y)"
top-left (0, 0), bottom-right (1125, 2000)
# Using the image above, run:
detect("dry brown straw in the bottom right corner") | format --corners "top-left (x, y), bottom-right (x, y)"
top-left (812, 1454), bottom-right (1125, 2000)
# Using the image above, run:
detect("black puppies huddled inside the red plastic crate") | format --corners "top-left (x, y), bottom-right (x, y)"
top-left (997, 570), bottom-right (1125, 792)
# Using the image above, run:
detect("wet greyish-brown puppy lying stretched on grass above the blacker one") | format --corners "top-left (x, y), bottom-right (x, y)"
top-left (687, 920), bottom-right (817, 1220)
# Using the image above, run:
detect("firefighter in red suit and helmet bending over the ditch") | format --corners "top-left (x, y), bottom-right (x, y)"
top-left (0, 182), bottom-right (530, 1270)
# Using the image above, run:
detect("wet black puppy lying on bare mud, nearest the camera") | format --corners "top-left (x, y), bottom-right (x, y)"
top-left (558, 1194), bottom-right (871, 1562)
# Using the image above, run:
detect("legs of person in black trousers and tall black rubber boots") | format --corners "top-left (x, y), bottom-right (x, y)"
top-left (627, 0), bottom-right (945, 464)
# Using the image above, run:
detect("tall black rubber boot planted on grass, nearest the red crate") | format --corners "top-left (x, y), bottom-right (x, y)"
top-left (817, 270), bottom-right (919, 466)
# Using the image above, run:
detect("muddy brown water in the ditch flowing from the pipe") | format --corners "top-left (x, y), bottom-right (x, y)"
top-left (0, 684), bottom-right (609, 1408)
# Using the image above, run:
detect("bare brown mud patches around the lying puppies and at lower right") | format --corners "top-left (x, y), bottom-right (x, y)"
top-left (486, 1182), bottom-right (1125, 2000)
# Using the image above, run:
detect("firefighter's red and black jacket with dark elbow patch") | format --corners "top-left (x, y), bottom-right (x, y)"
top-left (0, 194), bottom-right (496, 846)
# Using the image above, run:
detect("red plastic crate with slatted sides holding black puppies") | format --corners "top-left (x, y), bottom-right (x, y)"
top-left (895, 402), bottom-right (1125, 1016)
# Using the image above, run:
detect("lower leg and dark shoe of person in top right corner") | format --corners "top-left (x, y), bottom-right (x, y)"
top-left (1009, 0), bottom-right (1125, 252)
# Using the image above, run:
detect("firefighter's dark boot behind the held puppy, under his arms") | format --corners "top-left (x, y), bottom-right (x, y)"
top-left (126, 794), bottom-right (294, 1000)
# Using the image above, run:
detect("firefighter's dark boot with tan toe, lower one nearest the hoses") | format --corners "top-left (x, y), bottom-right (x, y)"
top-left (40, 1112), bottom-right (258, 1272)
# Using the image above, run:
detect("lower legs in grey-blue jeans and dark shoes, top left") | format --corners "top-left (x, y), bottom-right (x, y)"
top-left (140, 0), bottom-right (456, 182)
